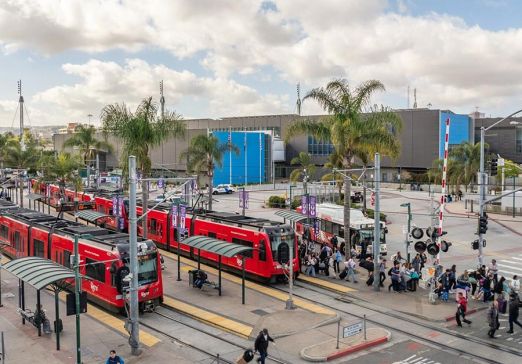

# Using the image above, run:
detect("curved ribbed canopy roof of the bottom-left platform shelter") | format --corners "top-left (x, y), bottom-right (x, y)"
top-left (2, 257), bottom-right (74, 291)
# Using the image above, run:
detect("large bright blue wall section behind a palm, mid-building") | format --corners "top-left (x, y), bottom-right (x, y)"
top-left (212, 131), bottom-right (271, 185)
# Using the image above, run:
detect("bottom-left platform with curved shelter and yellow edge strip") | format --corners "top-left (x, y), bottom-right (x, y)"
top-left (0, 260), bottom-right (194, 364)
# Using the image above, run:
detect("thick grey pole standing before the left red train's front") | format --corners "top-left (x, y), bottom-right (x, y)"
top-left (129, 155), bottom-right (139, 355)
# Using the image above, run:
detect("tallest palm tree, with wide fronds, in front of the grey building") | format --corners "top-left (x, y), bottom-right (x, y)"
top-left (286, 79), bottom-right (402, 251)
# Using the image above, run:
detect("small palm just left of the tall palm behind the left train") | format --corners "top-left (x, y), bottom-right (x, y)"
top-left (63, 125), bottom-right (112, 178)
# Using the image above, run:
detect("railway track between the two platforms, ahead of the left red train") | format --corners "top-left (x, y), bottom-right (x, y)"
top-left (140, 305), bottom-right (289, 364)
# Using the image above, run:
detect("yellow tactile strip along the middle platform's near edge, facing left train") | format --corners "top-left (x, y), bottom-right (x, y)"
top-left (163, 296), bottom-right (254, 338)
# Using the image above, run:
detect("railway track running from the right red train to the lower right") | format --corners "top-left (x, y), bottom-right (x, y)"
top-left (273, 281), bottom-right (522, 364)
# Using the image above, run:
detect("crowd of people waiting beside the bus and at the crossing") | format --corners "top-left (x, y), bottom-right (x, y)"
top-left (300, 237), bottom-right (522, 338)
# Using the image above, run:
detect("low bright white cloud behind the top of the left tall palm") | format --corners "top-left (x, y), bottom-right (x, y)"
top-left (32, 59), bottom-right (288, 122)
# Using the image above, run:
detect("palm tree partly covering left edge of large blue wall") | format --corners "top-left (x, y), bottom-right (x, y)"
top-left (179, 134), bottom-right (239, 210)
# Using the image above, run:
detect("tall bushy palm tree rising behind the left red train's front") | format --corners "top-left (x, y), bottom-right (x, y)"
top-left (101, 97), bottom-right (186, 238)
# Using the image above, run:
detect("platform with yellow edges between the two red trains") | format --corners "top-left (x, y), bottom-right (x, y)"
top-left (159, 253), bottom-right (339, 339)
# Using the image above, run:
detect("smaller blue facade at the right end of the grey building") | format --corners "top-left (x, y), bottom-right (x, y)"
top-left (439, 111), bottom-right (474, 158)
